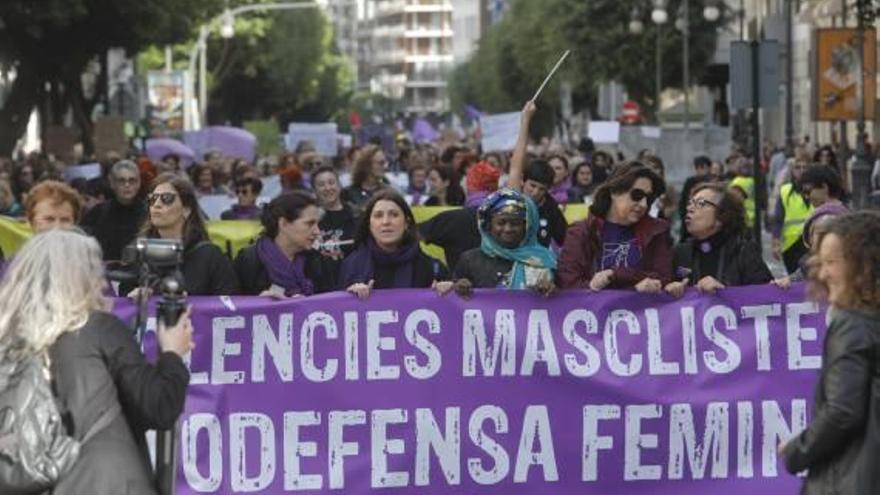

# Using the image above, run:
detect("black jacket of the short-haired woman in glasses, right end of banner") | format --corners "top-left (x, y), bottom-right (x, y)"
top-left (672, 237), bottom-right (773, 287)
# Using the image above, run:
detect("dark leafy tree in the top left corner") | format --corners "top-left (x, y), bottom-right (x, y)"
top-left (0, 0), bottom-right (223, 155)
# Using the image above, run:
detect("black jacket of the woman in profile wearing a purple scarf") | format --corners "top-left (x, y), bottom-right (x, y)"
top-left (235, 245), bottom-right (339, 295)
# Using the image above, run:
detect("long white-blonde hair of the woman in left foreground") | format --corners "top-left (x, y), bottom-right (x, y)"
top-left (0, 229), bottom-right (110, 353)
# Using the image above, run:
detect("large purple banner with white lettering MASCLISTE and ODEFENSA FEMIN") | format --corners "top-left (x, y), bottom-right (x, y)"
top-left (118, 287), bottom-right (825, 495)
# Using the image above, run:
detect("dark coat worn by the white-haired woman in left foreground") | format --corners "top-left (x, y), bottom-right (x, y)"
top-left (49, 312), bottom-right (189, 495)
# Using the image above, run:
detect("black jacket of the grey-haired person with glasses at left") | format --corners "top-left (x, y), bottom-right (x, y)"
top-left (81, 198), bottom-right (147, 261)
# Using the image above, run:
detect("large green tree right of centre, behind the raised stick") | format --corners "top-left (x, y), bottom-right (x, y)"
top-left (450, 0), bottom-right (725, 129)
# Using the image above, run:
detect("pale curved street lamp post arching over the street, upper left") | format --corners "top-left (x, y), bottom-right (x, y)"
top-left (189, 2), bottom-right (321, 130)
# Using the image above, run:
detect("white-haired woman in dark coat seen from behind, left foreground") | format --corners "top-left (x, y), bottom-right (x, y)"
top-left (0, 229), bottom-right (192, 494)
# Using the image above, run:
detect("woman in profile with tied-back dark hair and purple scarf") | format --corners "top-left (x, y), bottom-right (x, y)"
top-left (235, 192), bottom-right (336, 297)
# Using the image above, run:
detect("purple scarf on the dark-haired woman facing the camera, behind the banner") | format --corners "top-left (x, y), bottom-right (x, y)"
top-left (342, 237), bottom-right (420, 289)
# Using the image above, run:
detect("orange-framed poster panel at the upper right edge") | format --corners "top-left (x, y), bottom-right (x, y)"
top-left (813, 28), bottom-right (877, 121)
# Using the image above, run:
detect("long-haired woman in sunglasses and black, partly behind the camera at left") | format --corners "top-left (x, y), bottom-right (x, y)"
top-left (119, 173), bottom-right (238, 296)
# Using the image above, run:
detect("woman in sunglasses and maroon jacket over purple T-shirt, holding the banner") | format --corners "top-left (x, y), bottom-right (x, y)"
top-left (558, 161), bottom-right (672, 293)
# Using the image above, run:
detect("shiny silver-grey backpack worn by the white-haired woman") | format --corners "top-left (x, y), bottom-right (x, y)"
top-left (0, 354), bottom-right (121, 494)
